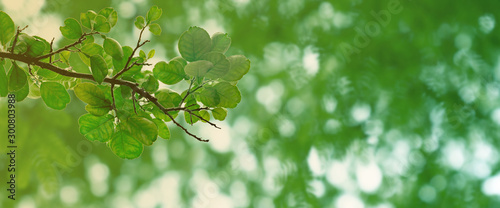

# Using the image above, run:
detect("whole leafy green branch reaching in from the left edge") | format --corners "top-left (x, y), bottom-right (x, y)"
top-left (0, 6), bottom-right (250, 159)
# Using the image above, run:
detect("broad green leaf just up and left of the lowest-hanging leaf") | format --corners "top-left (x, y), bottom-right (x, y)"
top-left (78, 114), bottom-right (114, 142)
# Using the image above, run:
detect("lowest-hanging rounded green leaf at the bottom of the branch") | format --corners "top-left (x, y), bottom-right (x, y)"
top-left (109, 131), bottom-right (144, 159)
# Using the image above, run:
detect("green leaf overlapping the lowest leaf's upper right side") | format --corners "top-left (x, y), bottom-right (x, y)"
top-left (124, 116), bottom-right (158, 146)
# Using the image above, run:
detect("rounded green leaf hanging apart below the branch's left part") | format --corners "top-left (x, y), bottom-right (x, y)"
top-left (40, 82), bottom-right (71, 110)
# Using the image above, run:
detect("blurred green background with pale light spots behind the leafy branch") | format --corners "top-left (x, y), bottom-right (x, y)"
top-left (0, 0), bottom-right (500, 208)
